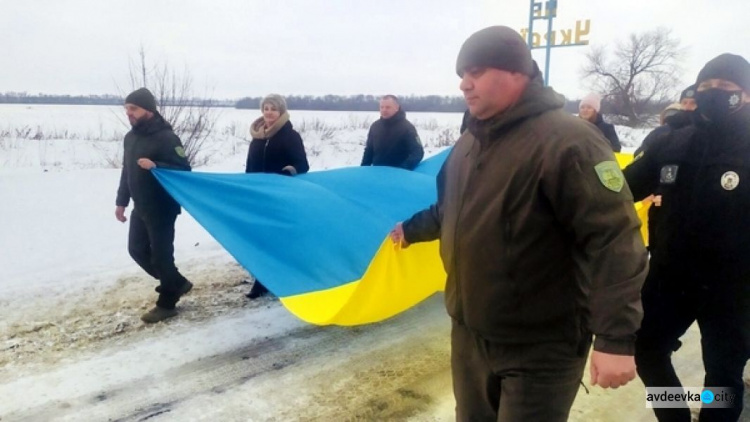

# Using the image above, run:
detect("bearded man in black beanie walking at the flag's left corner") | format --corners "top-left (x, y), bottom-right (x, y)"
top-left (115, 88), bottom-right (193, 323)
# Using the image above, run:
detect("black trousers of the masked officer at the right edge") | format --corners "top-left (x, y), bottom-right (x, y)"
top-left (635, 269), bottom-right (750, 422)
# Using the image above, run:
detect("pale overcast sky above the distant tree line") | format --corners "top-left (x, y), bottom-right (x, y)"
top-left (0, 0), bottom-right (750, 98)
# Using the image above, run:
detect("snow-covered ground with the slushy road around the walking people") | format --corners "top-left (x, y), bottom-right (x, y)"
top-left (0, 105), bottom-right (744, 422)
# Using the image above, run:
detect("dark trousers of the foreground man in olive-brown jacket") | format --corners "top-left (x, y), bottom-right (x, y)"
top-left (451, 320), bottom-right (591, 422)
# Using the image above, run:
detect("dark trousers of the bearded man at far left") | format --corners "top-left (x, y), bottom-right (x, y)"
top-left (128, 209), bottom-right (187, 309)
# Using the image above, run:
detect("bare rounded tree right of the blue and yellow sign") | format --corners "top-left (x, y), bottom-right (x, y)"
top-left (581, 28), bottom-right (684, 126)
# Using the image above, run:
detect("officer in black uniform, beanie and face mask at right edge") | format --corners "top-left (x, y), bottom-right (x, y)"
top-left (625, 54), bottom-right (750, 421)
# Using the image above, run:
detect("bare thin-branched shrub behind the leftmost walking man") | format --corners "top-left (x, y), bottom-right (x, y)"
top-left (121, 46), bottom-right (217, 166)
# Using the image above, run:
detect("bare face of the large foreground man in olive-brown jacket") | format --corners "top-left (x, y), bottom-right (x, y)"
top-left (459, 67), bottom-right (529, 120)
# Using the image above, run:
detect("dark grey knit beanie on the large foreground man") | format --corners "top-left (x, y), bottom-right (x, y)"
top-left (456, 26), bottom-right (535, 77)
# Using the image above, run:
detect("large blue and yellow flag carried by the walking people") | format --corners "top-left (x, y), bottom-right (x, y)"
top-left (153, 149), bottom-right (648, 325)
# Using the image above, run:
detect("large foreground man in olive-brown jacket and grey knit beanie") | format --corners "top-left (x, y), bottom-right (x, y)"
top-left (391, 26), bottom-right (648, 421)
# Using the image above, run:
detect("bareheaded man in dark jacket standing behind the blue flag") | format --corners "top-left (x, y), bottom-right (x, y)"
top-left (362, 95), bottom-right (424, 170)
